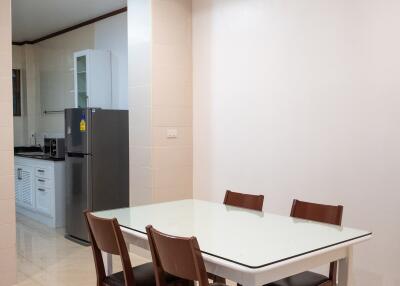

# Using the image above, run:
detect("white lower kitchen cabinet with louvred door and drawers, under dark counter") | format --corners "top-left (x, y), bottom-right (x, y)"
top-left (15, 156), bottom-right (65, 227)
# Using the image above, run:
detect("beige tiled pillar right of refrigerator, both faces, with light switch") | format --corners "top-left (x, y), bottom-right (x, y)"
top-left (128, 0), bottom-right (192, 207)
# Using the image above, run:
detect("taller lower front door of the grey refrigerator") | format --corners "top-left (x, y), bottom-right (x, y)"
top-left (66, 155), bottom-right (92, 241)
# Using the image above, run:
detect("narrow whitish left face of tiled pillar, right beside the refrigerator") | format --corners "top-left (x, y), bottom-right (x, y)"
top-left (128, 0), bottom-right (152, 205)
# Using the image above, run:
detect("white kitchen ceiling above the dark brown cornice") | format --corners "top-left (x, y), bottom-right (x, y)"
top-left (12, 0), bottom-right (127, 42)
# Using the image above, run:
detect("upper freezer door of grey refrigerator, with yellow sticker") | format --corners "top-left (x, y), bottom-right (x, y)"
top-left (65, 108), bottom-right (92, 154)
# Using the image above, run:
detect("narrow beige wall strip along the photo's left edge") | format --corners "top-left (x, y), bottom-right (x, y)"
top-left (0, 0), bottom-right (16, 286)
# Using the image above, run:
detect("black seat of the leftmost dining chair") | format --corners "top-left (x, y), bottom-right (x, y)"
top-left (104, 262), bottom-right (180, 286)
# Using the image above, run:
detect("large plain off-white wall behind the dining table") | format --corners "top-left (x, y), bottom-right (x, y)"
top-left (193, 0), bottom-right (400, 286)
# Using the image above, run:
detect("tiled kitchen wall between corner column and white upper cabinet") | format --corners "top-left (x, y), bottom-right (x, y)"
top-left (33, 25), bottom-right (95, 137)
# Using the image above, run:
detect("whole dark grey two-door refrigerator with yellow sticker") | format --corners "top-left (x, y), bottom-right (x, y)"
top-left (65, 108), bottom-right (129, 244)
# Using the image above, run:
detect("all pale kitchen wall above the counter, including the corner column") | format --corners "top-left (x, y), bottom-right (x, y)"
top-left (12, 25), bottom-right (94, 146)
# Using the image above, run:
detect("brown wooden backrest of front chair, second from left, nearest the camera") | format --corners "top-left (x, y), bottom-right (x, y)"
top-left (146, 225), bottom-right (209, 286)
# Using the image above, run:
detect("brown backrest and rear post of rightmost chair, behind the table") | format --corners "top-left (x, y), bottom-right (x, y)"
top-left (290, 200), bottom-right (343, 283)
